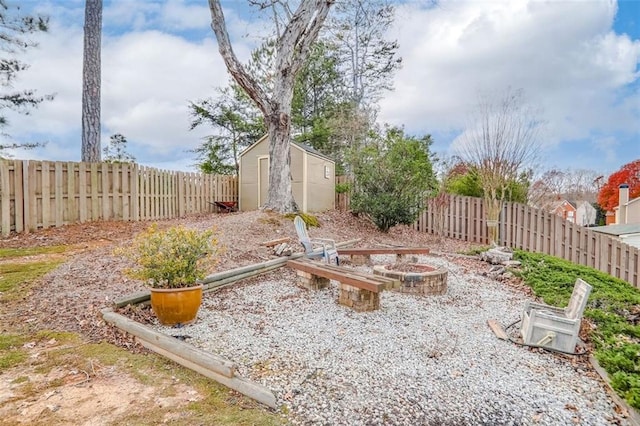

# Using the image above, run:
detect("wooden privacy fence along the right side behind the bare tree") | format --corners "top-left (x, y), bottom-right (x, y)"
top-left (413, 196), bottom-right (640, 287)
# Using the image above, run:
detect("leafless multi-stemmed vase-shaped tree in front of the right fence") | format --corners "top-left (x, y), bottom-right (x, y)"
top-left (458, 88), bottom-right (543, 244)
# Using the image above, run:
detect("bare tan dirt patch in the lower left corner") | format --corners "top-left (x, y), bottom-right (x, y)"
top-left (0, 339), bottom-right (202, 425)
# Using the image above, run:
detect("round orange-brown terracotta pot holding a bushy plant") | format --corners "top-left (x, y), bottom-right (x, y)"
top-left (151, 285), bottom-right (202, 325)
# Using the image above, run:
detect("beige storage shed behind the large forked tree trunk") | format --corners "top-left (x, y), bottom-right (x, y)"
top-left (238, 135), bottom-right (336, 213)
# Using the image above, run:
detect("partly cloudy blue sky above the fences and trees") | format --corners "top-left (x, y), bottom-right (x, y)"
top-left (4, 0), bottom-right (640, 174)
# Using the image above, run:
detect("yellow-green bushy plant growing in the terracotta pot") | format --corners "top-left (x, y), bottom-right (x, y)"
top-left (116, 224), bottom-right (218, 288)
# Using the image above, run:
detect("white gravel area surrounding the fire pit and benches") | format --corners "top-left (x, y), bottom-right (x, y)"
top-left (156, 256), bottom-right (628, 425)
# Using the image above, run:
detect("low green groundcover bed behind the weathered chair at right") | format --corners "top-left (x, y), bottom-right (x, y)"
top-left (515, 251), bottom-right (640, 408)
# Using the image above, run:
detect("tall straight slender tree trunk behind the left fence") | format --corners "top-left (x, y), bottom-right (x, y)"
top-left (82, 0), bottom-right (102, 163)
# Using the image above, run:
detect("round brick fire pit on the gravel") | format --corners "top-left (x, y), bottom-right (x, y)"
top-left (373, 263), bottom-right (447, 296)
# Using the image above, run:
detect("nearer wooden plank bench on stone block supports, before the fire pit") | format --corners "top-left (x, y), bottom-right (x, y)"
top-left (287, 259), bottom-right (400, 312)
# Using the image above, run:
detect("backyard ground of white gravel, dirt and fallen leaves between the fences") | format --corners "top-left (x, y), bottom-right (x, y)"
top-left (0, 212), bottom-right (629, 425)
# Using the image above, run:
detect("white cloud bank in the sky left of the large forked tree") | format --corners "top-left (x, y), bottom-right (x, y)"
top-left (8, 2), bottom-right (260, 167)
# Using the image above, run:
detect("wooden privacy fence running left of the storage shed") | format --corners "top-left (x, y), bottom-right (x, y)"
top-left (0, 160), bottom-right (238, 236)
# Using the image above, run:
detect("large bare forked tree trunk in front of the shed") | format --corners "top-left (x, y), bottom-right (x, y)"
top-left (209, 0), bottom-right (335, 212)
